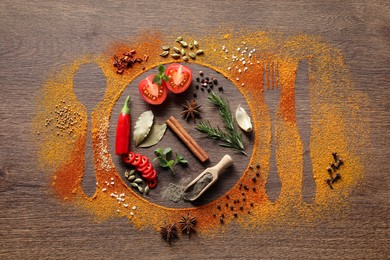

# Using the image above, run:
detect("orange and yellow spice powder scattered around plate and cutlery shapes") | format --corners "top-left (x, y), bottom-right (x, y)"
top-left (33, 30), bottom-right (369, 234)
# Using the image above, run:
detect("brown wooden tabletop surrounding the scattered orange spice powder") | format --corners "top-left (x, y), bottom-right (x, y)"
top-left (0, 0), bottom-right (390, 259)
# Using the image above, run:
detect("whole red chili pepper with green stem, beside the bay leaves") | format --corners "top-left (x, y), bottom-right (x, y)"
top-left (115, 96), bottom-right (130, 154)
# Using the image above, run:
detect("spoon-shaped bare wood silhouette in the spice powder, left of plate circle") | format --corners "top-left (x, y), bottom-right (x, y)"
top-left (73, 64), bottom-right (107, 197)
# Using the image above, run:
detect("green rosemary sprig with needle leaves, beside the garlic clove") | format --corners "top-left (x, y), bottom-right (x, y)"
top-left (195, 92), bottom-right (246, 155)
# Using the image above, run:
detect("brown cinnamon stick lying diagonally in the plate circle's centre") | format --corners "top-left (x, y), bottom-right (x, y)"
top-left (166, 116), bottom-right (209, 162)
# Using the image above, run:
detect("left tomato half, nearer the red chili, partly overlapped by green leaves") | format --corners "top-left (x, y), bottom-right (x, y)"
top-left (138, 75), bottom-right (168, 105)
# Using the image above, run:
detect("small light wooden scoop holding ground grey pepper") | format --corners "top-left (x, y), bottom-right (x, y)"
top-left (183, 154), bottom-right (233, 201)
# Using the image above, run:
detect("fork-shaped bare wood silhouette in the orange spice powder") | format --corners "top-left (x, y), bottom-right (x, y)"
top-left (263, 60), bottom-right (281, 201)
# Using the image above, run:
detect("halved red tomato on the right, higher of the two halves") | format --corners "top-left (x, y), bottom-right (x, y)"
top-left (165, 63), bottom-right (192, 94)
